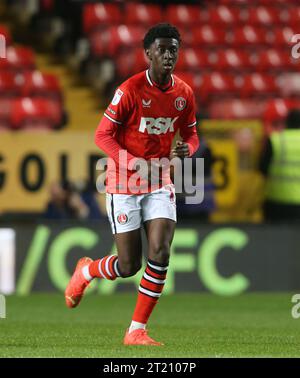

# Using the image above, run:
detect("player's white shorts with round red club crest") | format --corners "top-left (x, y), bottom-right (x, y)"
top-left (106, 185), bottom-right (176, 234)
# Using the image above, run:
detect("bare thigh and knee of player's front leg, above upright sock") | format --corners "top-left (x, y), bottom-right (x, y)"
top-left (144, 218), bottom-right (176, 264)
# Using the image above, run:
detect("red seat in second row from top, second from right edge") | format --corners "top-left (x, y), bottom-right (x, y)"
top-left (230, 25), bottom-right (272, 48)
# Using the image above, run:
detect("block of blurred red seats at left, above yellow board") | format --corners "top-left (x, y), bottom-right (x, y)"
top-left (0, 24), bottom-right (66, 130)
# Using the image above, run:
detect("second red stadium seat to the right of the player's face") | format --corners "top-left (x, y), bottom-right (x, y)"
top-left (212, 49), bottom-right (253, 71)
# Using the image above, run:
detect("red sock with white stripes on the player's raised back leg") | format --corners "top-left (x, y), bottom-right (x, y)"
top-left (89, 255), bottom-right (120, 280)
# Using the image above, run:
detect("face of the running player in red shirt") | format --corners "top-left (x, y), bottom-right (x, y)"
top-left (146, 38), bottom-right (179, 75)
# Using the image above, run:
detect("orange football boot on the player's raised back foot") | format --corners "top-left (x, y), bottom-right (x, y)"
top-left (65, 257), bottom-right (93, 308)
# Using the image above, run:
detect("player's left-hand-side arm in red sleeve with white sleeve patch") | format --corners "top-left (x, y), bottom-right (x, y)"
top-left (95, 89), bottom-right (137, 168)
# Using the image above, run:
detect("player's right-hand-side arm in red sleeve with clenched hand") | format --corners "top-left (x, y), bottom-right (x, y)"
top-left (172, 94), bottom-right (199, 158)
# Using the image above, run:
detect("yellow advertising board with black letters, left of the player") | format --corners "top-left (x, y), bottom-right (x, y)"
top-left (0, 131), bottom-right (101, 213)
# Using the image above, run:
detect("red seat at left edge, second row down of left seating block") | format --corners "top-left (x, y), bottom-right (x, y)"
top-left (0, 46), bottom-right (36, 72)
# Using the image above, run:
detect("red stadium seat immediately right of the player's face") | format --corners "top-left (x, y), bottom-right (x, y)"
top-left (176, 48), bottom-right (211, 71)
